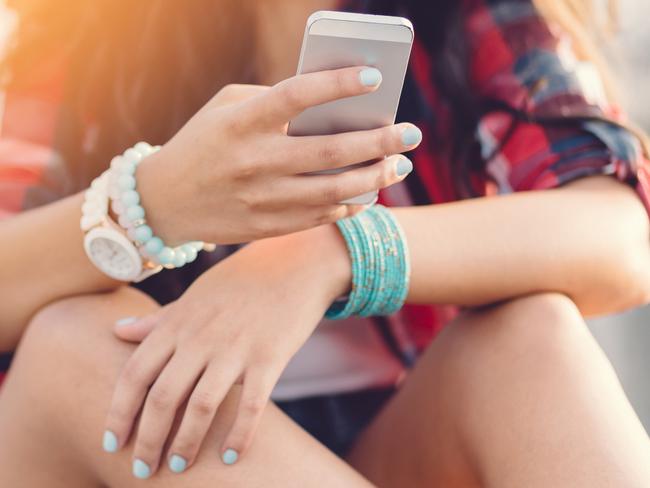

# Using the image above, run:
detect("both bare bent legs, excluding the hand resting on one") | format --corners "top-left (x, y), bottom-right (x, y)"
top-left (0, 289), bottom-right (650, 488)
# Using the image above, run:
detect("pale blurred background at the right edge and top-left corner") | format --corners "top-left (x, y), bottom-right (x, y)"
top-left (0, 0), bottom-right (650, 432)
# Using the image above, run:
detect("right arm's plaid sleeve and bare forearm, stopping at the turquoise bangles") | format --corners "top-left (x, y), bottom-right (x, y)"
top-left (396, 0), bottom-right (650, 315)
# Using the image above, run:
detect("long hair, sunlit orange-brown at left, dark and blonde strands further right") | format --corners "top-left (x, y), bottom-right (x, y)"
top-left (2, 0), bottom-right (613, 194)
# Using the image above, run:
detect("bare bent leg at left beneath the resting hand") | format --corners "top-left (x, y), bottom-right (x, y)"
top-left (0, 289), bottom-right (370, 487)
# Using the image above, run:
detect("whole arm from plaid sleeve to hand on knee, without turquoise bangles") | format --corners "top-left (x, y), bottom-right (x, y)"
top-left (101, 0), bottom-right (650, 472)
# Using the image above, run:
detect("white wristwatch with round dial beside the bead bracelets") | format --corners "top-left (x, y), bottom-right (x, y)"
top-left (81, 172), bottom-right (162, 282)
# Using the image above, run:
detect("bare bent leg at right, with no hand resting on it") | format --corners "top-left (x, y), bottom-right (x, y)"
top-left (350, 295), bottom-right (650, 488)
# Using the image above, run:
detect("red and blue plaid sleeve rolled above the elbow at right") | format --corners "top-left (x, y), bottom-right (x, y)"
top-left (466, 0), bottom-right (650, 214)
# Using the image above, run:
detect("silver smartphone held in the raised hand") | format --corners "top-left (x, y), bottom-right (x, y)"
top-left (288, 11), bottom-right (414, 205)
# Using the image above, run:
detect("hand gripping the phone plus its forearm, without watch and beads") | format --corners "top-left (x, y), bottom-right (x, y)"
top-left (0, 68), bottom-right (417, 350)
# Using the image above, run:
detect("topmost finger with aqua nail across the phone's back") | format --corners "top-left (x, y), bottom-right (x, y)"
top-left (250, 66), bottom-right (382, 125)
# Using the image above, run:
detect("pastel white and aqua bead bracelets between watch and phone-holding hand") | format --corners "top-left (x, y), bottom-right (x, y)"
top-left (108, 142), bottom-right (205, 268)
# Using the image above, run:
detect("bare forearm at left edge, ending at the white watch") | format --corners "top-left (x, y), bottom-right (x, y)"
top-left (0, 194), bottom-right (119, 344)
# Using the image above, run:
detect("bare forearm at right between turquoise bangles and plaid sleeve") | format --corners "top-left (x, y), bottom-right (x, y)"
top-left (322, 177), bottom-right (650, 315)
